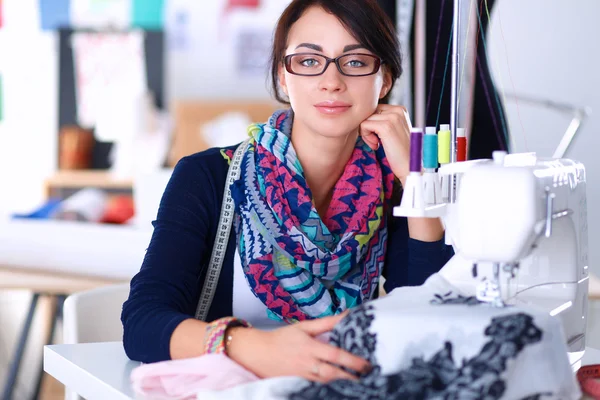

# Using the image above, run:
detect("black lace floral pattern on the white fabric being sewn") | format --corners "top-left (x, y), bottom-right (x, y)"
top-left (289, 304), bottom-right (556, 400)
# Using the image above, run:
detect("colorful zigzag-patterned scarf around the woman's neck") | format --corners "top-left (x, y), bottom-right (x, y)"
top-left (231, 110), bottom-right (394, 323)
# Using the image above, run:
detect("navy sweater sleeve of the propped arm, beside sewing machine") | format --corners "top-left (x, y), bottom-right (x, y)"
top-left (383, 218), bottom-right (454, 293)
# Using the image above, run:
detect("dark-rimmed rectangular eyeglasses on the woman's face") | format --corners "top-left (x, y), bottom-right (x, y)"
top-left (283, 53), bottom-right (382, 76)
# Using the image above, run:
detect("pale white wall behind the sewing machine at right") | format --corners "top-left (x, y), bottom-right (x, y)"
top-left (488, 0), bottom-right (600, 275)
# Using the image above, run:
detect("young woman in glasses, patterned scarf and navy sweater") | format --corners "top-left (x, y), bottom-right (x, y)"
top-left (122, 0), bottom-right (451, 388)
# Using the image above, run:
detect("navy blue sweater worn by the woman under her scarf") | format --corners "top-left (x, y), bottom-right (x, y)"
top-left (121, 146), bottom-right (452, 362)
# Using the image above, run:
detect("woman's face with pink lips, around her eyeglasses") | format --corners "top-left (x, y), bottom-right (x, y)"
top-left (279, 7), bottom-right (391, 141)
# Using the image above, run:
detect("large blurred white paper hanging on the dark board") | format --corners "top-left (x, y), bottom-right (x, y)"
top-left (72, 31), bottom-right (146, 128)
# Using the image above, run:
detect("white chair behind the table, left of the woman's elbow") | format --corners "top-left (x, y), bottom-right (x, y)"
top-left (63, 283), bottom-right (129, 400)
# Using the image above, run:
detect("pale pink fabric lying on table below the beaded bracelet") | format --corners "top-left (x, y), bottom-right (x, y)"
top-left (131, 354), bottom-right (259, 400)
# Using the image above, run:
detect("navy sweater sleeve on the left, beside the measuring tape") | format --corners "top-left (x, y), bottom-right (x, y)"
top-left (121, 156), bottom-right (216, 363)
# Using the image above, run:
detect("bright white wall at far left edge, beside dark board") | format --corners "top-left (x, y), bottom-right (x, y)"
top-left (0, 0), bottom-right (58, 216)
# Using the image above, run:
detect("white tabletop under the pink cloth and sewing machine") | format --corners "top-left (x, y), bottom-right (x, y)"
top-left (44, 342), bottom-right (600, 400)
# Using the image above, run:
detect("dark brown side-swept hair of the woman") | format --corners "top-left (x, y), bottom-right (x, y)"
top-left (271, 0), bottom-right (402, 104)
